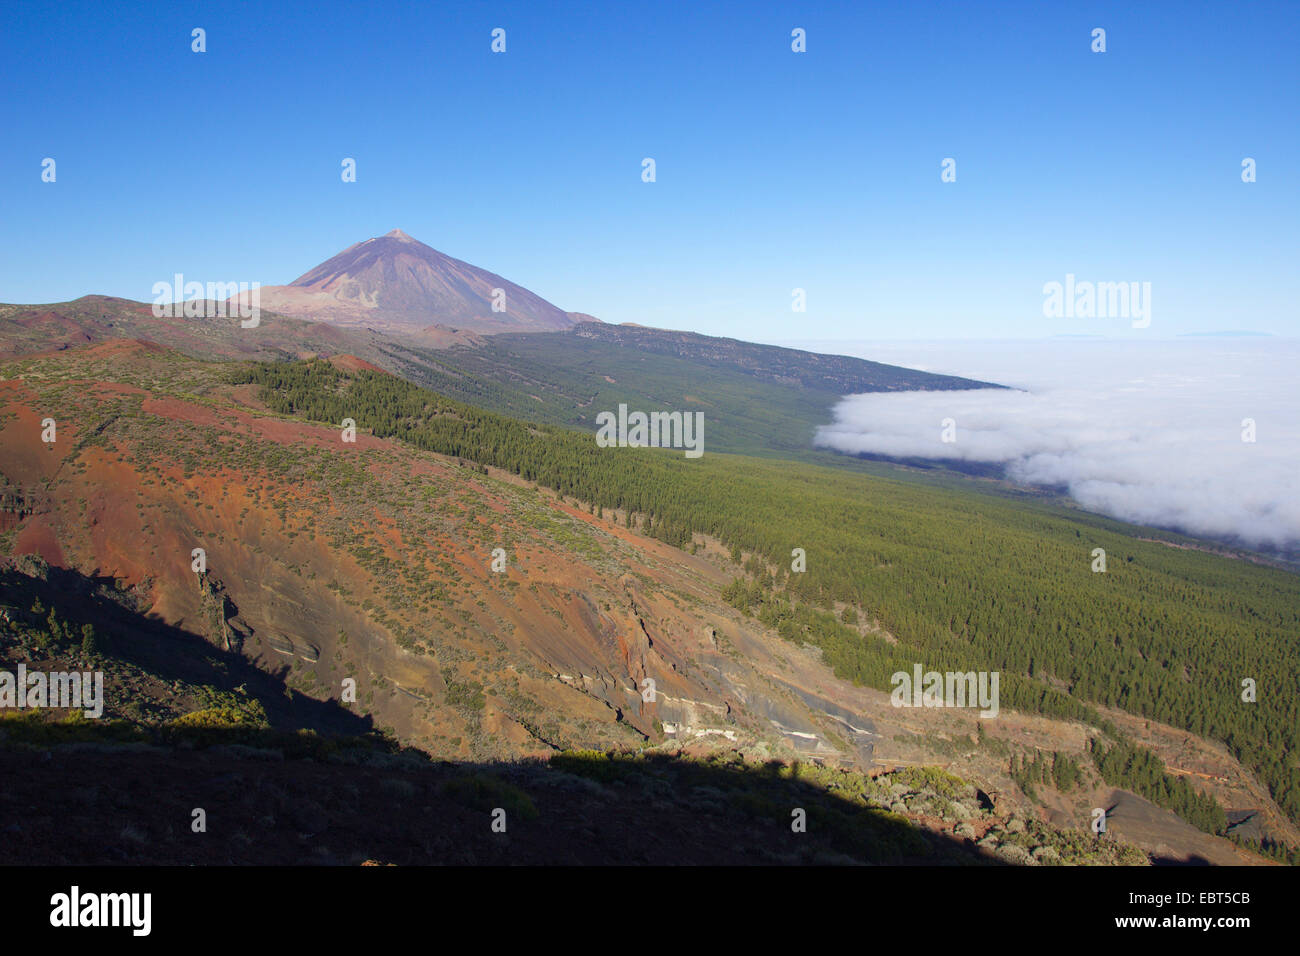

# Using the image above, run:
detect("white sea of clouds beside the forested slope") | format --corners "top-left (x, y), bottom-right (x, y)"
top-left (800, 337), bottom-right (1300, 550)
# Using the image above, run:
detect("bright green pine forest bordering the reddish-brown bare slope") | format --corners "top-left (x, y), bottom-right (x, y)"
top-left (234, 360), bottom-right (1300, 831)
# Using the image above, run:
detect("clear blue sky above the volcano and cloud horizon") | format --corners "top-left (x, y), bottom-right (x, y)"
top-left (0, 0), bottom-right (1300, 341)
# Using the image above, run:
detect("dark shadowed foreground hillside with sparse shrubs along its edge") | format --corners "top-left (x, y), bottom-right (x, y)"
top-left (0, 558), bottom-right (1144, 865)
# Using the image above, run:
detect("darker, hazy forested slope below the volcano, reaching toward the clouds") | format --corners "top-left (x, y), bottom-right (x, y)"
top-left (380, 323), bottom-right (1000, 463)
